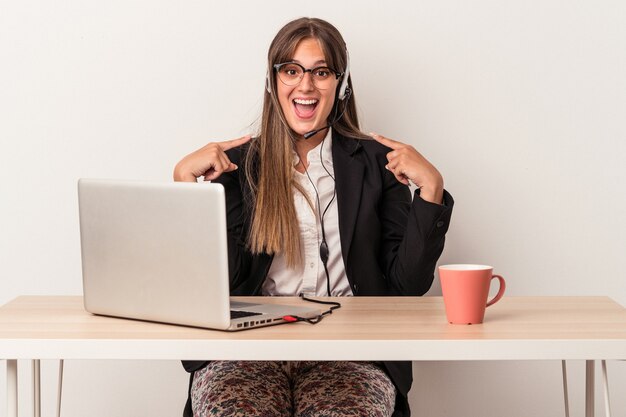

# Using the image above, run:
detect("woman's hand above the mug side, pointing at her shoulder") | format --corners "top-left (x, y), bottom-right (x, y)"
top-left (370, 133), bottom-right (443, 204)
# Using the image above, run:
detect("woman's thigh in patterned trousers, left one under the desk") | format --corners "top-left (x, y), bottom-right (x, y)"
top-left (191, 361), bottom-right (292, 417)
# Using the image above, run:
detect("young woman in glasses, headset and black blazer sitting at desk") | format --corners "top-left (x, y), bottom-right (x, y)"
top-left (174, 18), bottom-right (453, 417)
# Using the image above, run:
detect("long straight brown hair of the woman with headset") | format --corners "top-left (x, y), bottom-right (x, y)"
top-left (245, 18), bottom-right (367, 267)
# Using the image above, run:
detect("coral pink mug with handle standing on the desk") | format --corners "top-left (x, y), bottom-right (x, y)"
top-left (439, 264), bottom-right (506, 324)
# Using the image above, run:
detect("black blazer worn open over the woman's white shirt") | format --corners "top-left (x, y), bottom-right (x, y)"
top-left (183, 131), bottom-right (454, 417)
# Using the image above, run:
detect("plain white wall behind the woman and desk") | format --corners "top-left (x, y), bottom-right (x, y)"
top-left (0, 0), bottom-right (626, 417)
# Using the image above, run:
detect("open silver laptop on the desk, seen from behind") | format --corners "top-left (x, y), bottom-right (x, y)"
top-left (78, 179), bottom-right (319, 331)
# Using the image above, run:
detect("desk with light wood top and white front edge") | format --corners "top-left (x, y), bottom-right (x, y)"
top-left (0, 296), bottom-right (626, 417)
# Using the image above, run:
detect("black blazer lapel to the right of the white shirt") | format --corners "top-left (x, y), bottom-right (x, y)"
top-left (333, 130), bottom-right (365, 268)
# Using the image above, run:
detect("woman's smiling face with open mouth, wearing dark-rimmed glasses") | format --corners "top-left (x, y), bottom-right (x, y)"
top-left (275, 38), bottom-right (339, 135)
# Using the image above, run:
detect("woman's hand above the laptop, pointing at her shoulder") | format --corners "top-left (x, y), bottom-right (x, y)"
top-left (174, 135), bottom-right (252, 182)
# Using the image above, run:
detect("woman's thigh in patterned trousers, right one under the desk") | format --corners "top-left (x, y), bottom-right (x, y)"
top-left (293, 362), bottom-right (396, 417)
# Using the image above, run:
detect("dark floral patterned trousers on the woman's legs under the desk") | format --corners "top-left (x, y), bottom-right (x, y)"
top-left (191, 361), bottom-right (396, 417)
